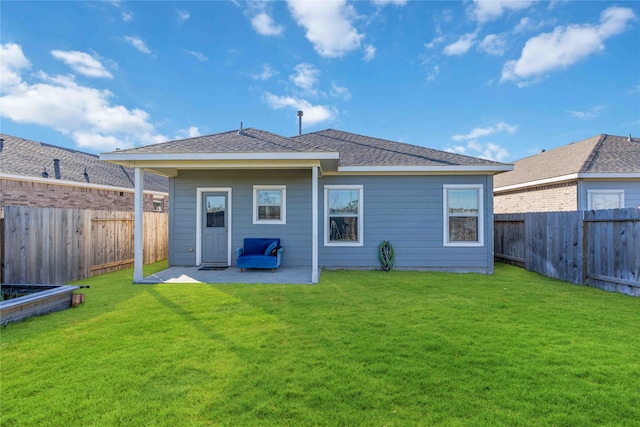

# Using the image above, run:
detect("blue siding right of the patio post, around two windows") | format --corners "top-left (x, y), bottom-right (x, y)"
top-left (318, 176), bottom-right (493, 273)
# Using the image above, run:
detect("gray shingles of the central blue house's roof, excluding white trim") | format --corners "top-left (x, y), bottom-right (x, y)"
top-left (110, 128), bottom-right (504, 167)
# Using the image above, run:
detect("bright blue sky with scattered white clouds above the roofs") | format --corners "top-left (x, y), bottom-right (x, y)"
top-left (0, 0), bottom-right (640, 162)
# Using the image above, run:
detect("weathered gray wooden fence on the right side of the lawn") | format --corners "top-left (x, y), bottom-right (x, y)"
top-left (494, 208), bottom-right (640, 296)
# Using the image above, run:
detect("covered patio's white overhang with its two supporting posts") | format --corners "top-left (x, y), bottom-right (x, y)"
top-left (100, 152), bottom-right (340, 283)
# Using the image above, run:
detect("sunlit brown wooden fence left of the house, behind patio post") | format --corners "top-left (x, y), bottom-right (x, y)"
top-left (0, 206), bottom-right (168, 283)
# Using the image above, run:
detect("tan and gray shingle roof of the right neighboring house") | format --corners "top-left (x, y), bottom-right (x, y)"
top-left (494, 134), bottom-right (640, 190)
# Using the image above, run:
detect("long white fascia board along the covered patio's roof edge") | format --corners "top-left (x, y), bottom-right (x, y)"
top-left (100, 151), bottom-right (340, 162)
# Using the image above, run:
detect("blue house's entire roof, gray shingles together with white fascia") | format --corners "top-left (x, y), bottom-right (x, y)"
top-left (101, 128), bottom-right (512, 174)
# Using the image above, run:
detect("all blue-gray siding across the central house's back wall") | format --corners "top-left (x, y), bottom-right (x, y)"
top-left (169, 170), bottom-right (493, 273)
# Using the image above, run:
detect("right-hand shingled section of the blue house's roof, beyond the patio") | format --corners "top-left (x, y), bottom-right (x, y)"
top-left (293, 129), bottom-right (504, 166)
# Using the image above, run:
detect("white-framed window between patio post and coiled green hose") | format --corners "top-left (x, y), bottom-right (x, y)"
top-left (324, 185), bottom-right (363, 246)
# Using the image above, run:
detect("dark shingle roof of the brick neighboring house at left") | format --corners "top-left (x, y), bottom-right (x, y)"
top-left (0, 134), bottom-right (169, 193)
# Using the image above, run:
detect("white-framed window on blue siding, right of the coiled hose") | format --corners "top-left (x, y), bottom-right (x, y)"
top-left (443, 185), bottom-right (484, 246)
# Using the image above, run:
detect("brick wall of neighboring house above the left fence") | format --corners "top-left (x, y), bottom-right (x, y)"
top-left (0, 179), bottom-right (168, 212)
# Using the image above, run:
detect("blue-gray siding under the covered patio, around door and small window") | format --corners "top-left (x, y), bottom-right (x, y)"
top-left (169, 170), bottom-right (311, 267)
